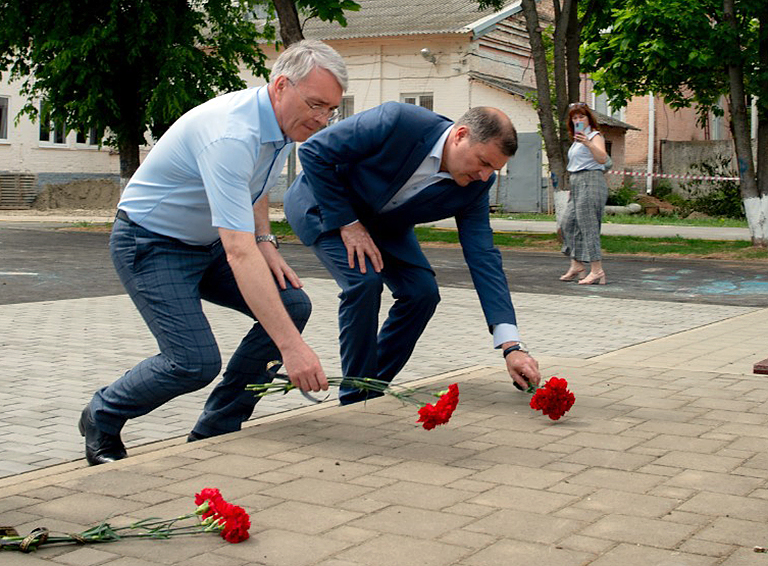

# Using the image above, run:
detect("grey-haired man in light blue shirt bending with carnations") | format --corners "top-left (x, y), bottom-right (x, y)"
top-left (79, 41), bottom-right (347, 465)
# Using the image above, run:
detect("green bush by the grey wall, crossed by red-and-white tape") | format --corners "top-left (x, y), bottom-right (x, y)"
top-left (683, 155), bottom-right (745, 218)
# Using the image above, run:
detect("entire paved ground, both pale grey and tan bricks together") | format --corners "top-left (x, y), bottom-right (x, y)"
top-left (0, 272), bottom-right (768, 566)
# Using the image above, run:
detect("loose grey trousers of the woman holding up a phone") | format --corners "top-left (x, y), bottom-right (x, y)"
top-left (560, 171), bottom-right (608, 262)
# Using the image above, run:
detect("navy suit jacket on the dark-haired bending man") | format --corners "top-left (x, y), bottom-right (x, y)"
top-left (284, 102), bottom-right (516, 326)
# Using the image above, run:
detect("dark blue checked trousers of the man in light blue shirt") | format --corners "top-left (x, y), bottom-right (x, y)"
top-left (91, 219), bottom-right (312, 437)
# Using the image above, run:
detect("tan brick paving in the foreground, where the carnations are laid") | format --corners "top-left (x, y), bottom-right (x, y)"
top-left (0, 356), bottom-right (768, 566)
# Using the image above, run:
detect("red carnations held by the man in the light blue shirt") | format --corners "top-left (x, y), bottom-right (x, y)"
top-left (245, 374), bottom-right (459, 430)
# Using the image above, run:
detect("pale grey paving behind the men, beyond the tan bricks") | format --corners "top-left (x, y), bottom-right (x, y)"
top-left (0, 279), bottom-right (765, 477)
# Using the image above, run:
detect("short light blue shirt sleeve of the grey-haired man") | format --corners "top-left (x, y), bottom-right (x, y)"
top-left (197, 138), bottom-right (257, 233)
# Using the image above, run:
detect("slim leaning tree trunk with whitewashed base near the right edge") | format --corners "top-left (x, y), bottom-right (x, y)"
top-left (723, 0), bottom-right (768, 247)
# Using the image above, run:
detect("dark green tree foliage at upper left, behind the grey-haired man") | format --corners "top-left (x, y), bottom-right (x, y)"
top-left (0, 0), bottom-right (356, 179)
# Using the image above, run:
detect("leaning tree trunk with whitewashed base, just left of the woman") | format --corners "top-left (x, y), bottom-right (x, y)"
top-left (521, 0), bottom-right (568, 222)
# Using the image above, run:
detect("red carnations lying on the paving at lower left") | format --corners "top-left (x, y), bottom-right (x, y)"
top-left (0, 488), bottom-right (251, 553)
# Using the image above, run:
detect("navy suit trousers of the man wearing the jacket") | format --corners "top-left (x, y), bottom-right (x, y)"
top-left (312, 230), bottom-right (440, 405)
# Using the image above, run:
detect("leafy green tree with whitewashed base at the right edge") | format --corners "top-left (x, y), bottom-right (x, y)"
top-left (582, 0), bottom-right (768, 245)
